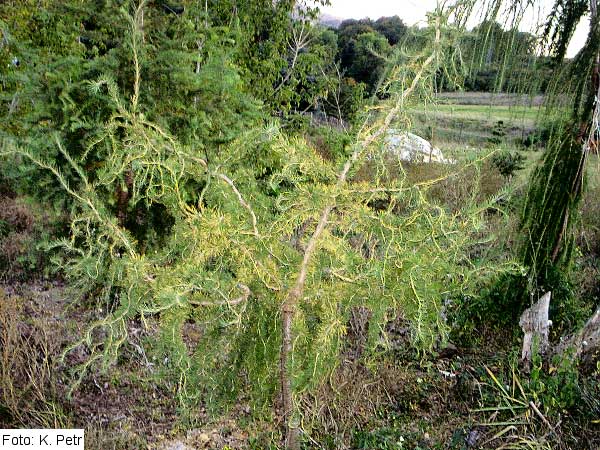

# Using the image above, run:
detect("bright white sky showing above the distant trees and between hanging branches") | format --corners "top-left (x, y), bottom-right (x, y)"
top-left (321, 0), bottom-right (588, 57)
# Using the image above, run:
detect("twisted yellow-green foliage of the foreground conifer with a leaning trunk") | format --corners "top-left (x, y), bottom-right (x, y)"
top-left (4, 3), bottom-right (515, 426)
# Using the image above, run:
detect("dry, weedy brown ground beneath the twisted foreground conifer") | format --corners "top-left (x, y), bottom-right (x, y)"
top-left (0, 281), bottom-right (600, 450)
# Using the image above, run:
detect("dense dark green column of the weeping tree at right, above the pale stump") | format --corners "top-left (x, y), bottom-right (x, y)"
top-left (521, 0), bottom-right (600, 306)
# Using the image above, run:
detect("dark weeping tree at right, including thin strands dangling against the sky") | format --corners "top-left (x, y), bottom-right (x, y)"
top-left (434, 0), bottom-right (600, 313)
